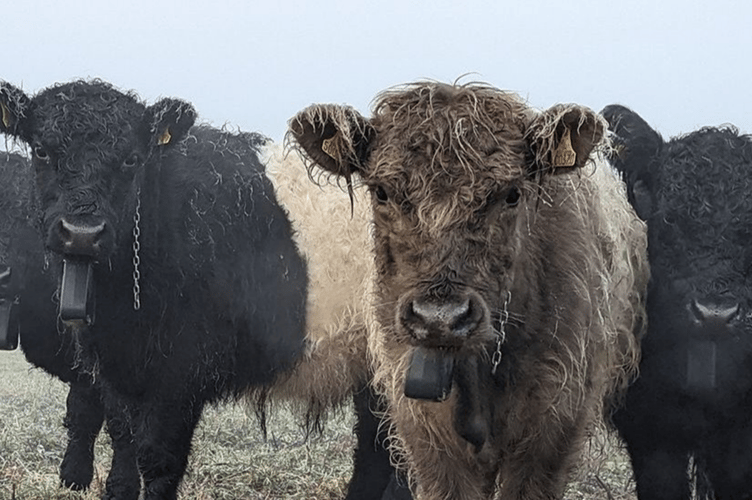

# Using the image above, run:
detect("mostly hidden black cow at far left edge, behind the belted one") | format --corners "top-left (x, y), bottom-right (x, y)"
top-left (0, 153), bottom-right (128, 489)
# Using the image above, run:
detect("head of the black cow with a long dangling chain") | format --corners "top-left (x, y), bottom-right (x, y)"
top-left (0, 81), bottom-right (195, 261)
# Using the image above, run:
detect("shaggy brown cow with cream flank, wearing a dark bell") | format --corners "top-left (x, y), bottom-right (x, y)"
top-left (289, 83), bottom-right (648, 500)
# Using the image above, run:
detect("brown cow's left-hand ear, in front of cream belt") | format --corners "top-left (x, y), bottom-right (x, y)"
top-left (286, 104), bottom-right (375, 181)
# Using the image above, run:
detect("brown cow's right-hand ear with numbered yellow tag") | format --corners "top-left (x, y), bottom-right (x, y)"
top-left (526, 104), bottom-right (606, 178)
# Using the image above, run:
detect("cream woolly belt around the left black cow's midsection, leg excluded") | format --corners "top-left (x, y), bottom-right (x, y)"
top-left (265, 145), bottom-right (373, 410)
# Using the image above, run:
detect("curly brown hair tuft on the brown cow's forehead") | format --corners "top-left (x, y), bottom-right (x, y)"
top-left (366, 82), bottom-right (532, 230)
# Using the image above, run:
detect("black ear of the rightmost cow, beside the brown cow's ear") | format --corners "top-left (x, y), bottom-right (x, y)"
top-left (601, 104), bottom-right (663, 219)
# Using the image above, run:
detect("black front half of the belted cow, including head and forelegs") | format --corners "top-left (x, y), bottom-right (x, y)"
top-left (0, 81), bottom-right (307, 499)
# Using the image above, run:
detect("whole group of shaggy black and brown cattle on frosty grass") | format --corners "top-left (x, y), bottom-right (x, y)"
top-left (0, 80), bottom-right (752, 500)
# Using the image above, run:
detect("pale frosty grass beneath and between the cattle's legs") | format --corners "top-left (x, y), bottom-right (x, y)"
top-left (0, 351), bottom-right (635, 500)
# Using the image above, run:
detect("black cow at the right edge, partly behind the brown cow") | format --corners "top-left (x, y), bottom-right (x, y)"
top-left (603, 105), bottom-right (752, 500)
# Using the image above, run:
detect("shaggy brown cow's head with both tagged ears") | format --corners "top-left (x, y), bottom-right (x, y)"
top-left (291, 84), bottom-right (603, 351)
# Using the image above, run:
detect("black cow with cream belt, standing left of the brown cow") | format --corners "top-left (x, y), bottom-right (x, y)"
top-left (0, 81), bottom-right (406, 499)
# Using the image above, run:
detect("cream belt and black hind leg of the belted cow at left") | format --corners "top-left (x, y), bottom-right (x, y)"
top-left (264, 144), bottom-right (409, 500)
